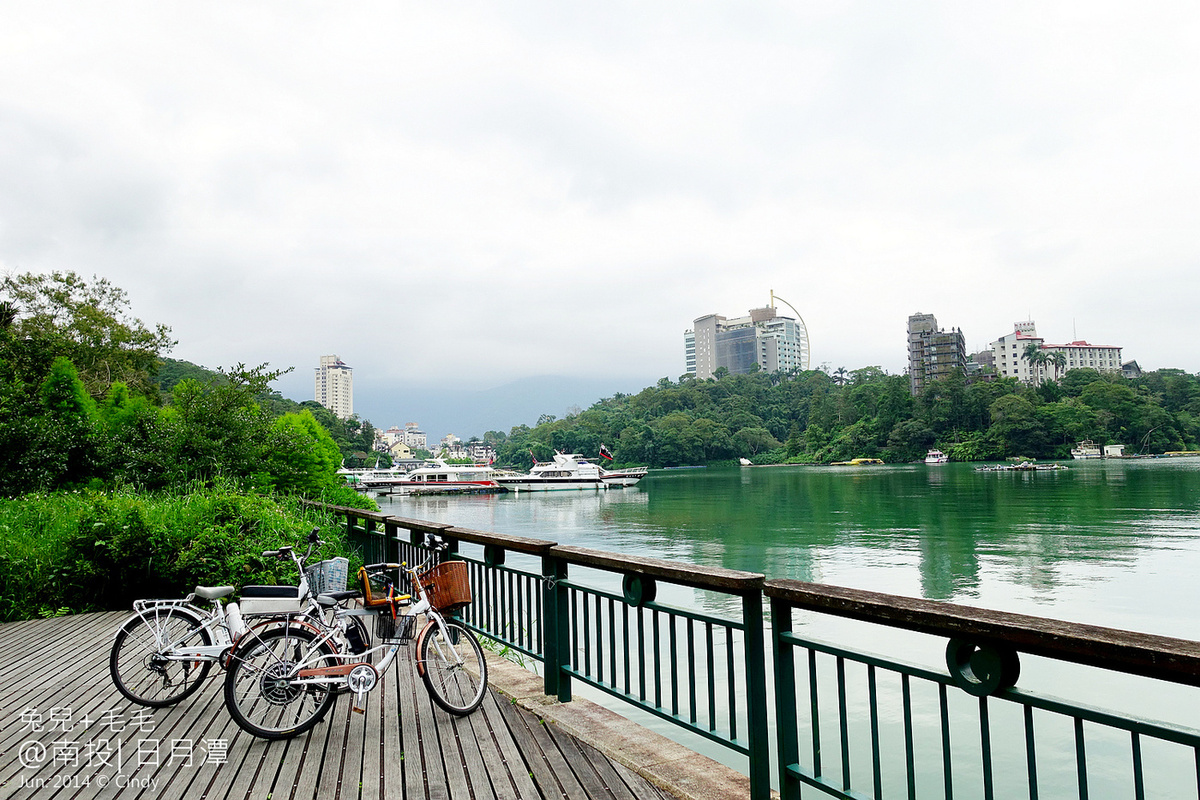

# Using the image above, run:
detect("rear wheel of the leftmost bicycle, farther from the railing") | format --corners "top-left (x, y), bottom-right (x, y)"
top-left (108, 608), bottom-right (212, 708)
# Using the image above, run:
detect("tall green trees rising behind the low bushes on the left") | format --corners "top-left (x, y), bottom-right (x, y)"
top-left (0, 272), bottom-right (373, 507)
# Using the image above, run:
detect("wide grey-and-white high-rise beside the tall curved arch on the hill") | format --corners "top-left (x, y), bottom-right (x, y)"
top-left (683, 306), bottom-right (809, 379)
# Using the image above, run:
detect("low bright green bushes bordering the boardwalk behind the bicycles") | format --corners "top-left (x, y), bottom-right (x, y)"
top-left (0, 485), bottom-right (354, 621)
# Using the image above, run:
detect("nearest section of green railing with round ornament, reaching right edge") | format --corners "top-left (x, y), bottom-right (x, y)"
top-left (764, 581), bottom-right (1200, 800)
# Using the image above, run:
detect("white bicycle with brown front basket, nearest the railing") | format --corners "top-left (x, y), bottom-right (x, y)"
top-left (224, 545), bottom-right (487, 739)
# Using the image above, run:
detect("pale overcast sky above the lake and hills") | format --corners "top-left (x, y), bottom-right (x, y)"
top-left (0, 0), bottom-right (1200, 423)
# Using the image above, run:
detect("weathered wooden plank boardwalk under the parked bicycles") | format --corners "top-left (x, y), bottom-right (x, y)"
top-left (0, 612), bottom-right (670, 800)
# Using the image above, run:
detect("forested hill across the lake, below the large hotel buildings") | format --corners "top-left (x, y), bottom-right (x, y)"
top-left (487, 367), bottom-right (1200, 467)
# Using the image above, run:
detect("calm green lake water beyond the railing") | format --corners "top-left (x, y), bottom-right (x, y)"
top-left (380, 458), bottom-right (1200, 796)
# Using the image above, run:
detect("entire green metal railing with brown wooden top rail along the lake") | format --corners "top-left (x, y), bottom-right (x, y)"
top-left (324, 509), bottom-right (1200, 800)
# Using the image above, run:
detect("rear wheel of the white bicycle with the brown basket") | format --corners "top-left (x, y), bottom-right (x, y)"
top-left (224, 627), bottom-right (337, 739)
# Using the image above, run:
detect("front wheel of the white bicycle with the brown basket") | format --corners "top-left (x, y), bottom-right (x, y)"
top-left (420, 620), bottom-right (487, 716)
